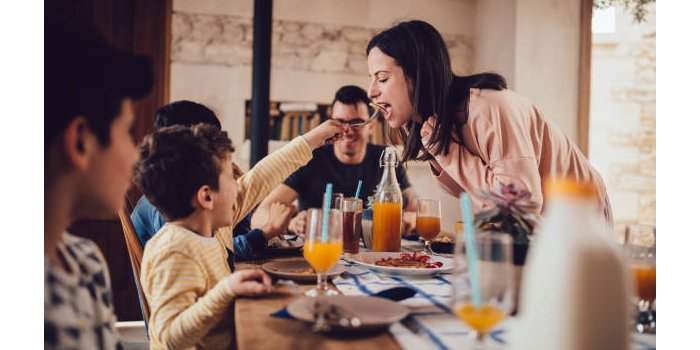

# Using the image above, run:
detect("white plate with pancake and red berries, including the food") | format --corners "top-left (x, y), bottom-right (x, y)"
top-left (348, 252), bottom-right (454, 276)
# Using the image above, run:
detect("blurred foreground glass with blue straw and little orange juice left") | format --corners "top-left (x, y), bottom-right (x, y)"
top-left (452, 232), bottom-right (515, 349)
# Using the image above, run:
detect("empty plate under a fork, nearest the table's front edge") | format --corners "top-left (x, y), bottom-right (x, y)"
top-left (287, 295), bottom-right (409, 330)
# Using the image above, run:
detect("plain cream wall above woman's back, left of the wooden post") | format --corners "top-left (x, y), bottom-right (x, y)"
top-left (474, 0), bottom-right (581, 141)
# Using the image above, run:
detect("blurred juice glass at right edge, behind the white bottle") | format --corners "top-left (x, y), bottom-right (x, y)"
top-left (625, 225), bottom-right (656, 334)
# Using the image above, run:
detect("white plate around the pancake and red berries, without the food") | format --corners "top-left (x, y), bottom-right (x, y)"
top-left (347, 252), bottom-right (454, 276)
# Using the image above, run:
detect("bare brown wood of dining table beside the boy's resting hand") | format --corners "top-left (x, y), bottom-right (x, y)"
top-left (234, 257), bottom-right (401, 350)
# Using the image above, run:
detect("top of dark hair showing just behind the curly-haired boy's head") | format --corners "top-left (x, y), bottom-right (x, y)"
top-left (153, 100), bottom-right (221, 130)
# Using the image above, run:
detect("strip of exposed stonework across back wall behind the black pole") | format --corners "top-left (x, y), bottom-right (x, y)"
top-left (172, 12), bottom-right (473, 76)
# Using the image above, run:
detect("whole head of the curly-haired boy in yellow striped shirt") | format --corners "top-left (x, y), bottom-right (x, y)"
top-left (134, 124), bottom-right (238, 229)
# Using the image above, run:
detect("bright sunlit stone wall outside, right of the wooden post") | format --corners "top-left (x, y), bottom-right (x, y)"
top-left (590, 9), bottom-right (656, 231)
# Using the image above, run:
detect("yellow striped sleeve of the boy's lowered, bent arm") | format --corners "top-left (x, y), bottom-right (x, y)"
top-left (141, 252), bottom-right (234, 349)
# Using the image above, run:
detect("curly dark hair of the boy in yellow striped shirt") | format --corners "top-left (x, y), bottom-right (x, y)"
top-left (134, 124), bottom-right (234, 220)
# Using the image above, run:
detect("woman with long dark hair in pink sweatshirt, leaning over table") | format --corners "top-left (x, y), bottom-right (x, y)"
top-left (367, 21), bottom-right (612, 221)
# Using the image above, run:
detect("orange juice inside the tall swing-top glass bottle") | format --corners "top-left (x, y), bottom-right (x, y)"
top-left (372, 202), bottom-right (402, 252)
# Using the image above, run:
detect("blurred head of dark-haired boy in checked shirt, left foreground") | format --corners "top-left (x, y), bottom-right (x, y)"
top-left (44, 15), bottom-right (152, 219)
